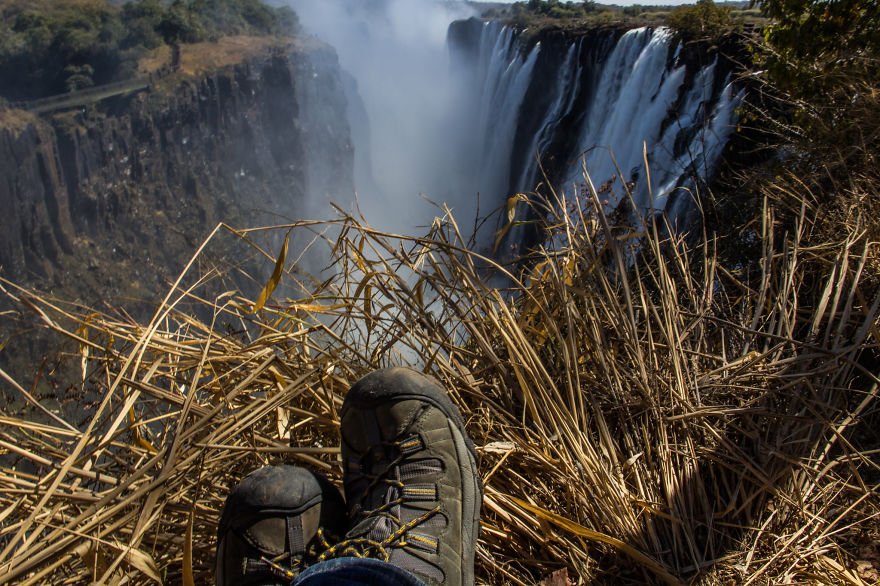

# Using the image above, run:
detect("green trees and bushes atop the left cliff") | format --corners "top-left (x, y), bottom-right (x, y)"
top-left (0, 0), bottom-right (297, 100)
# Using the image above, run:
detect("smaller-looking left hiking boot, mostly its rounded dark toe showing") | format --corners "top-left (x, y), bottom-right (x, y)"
top-left (215, 466), bottom-right (347, 586)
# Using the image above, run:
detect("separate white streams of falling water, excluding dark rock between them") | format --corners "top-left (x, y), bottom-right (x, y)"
top-left (460, 23), bottom-right (743, 233)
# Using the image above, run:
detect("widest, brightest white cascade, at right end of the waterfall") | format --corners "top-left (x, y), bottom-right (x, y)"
top-left (567, 28), bottom-right (742, 211)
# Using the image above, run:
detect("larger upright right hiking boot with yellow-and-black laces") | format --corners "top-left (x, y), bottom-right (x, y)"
top-left (324, 368), bottom-right (482, 586)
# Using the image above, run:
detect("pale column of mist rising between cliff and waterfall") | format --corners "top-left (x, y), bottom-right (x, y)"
top-left (289, 0), bottom-right (476, 231)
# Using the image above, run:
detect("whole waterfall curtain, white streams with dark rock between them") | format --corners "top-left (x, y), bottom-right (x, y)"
top-left (450, 21), bottom-right (743, 240)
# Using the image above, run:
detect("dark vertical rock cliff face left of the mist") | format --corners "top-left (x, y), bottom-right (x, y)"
top-left (0, 42), bottom-right (353, 300)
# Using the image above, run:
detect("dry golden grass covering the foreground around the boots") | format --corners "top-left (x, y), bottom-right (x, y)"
top-left (0, 176), bottom-right (880, 584)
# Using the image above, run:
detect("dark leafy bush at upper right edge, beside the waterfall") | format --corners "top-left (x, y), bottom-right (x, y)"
top-left (736, 0), bottom-right (880, 250)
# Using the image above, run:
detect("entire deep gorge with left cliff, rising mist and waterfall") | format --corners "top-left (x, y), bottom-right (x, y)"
top-left (0, 0), bottom-right (743, 300)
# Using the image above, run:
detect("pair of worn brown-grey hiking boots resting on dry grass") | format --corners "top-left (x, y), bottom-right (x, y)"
top-left (216, 368), bottom-right (482, 586)
